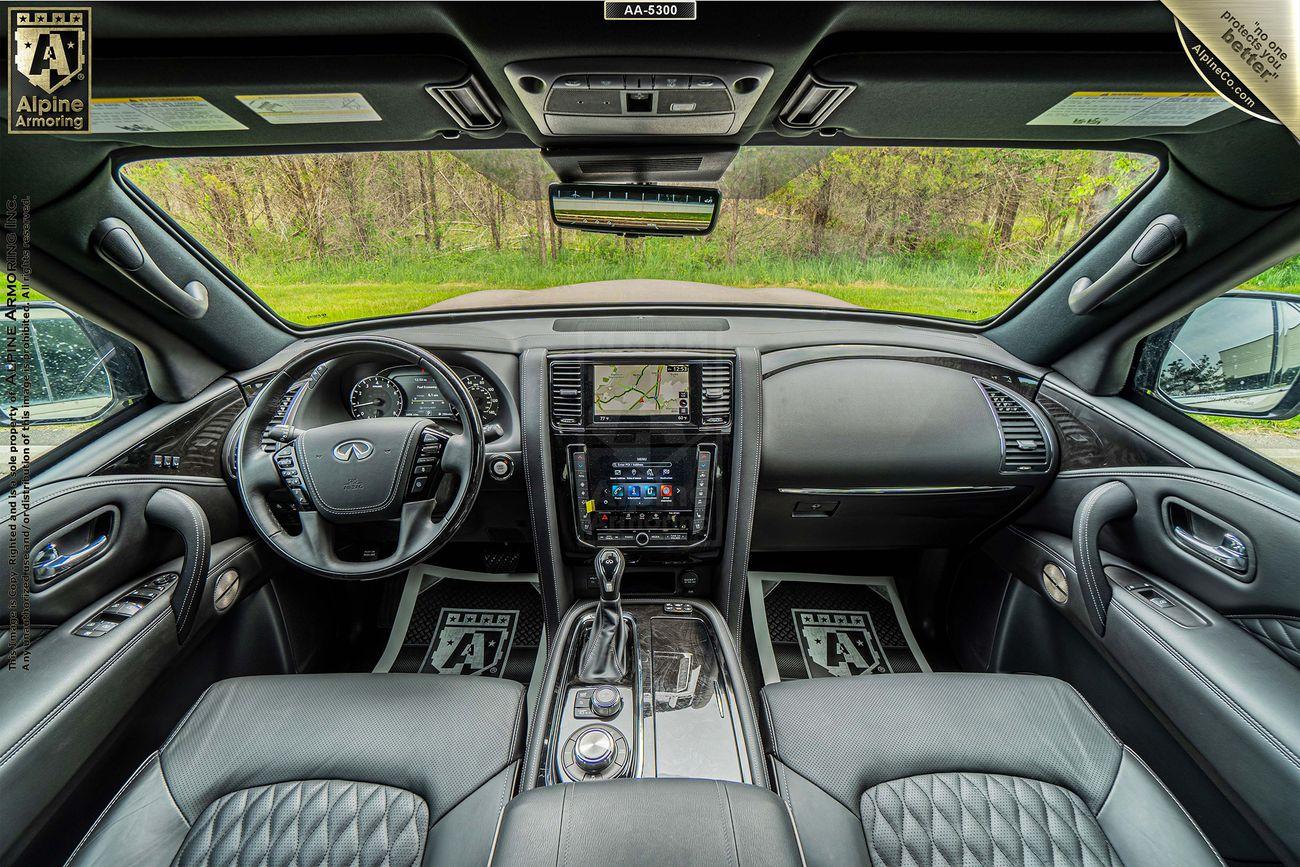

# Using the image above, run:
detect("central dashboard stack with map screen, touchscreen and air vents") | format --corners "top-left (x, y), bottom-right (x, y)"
top-left (547, 351), bottom-right (736, 595)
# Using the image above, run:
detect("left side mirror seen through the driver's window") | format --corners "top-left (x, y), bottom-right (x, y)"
top-left (0, 302), bottom-right (117, 426)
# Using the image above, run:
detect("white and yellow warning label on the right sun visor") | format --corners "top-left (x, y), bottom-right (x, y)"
top-left (1026, 91), bottom-right (1231, 126)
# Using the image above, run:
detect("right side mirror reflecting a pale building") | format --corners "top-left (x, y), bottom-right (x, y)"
top-left (1154, 292), bottom-right (1300, 419)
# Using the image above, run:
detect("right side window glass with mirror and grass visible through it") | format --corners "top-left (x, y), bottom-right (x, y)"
top-left (1135, 257), bottom-right (1300, 474)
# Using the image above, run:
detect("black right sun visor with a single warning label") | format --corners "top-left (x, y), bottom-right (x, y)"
top-left (790, 52), bottom-right (1249, 142)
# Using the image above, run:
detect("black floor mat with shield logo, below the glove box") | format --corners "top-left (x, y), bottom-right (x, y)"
top-left (750, 573), bottom-right (930, 682)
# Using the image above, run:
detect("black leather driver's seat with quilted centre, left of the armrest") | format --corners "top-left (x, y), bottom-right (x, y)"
top-left (69, 675), bottom-right (524, 867)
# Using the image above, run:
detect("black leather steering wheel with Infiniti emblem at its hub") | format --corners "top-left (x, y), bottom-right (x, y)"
top-left (235, 337), bottom-right (485, 578)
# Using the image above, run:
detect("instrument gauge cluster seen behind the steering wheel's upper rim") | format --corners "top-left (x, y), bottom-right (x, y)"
top-left (348, 368), bottom-right (501, 422)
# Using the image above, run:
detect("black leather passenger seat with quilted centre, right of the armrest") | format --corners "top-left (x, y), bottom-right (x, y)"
top-left (763, 673), bottom-right (1223, 867)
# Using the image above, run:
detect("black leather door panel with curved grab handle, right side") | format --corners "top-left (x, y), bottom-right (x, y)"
top-left (985, 467), bottom-right (1300, 858)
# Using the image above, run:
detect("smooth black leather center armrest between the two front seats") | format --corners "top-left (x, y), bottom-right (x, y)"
top-left (491, 779), bottom-right (803, 867)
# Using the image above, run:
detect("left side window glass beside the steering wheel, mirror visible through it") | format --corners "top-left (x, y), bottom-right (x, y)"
top-left (0, 302), bottom-right (148, 460)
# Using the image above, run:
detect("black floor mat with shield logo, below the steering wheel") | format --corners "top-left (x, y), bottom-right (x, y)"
top-left (387, 578), bottom-right (543, 685)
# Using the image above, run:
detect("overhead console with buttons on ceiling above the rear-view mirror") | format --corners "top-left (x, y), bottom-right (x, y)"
top-left (506, 58), bottom-right (772, 135)
